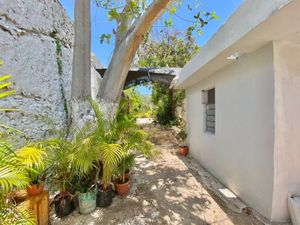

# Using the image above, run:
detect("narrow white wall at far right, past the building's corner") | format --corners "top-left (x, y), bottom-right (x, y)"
top-left (272, 42), bottom-right (300, 221)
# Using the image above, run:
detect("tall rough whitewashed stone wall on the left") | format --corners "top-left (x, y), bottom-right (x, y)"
top-left (0, 0), bottom-right (73, 139)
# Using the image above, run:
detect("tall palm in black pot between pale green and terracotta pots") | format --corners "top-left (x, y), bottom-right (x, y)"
top-left (90, 100), bottom-right (152, 201)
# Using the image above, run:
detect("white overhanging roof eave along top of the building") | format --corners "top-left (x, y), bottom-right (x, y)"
top-left (174, 0), bottom-right (300, 89)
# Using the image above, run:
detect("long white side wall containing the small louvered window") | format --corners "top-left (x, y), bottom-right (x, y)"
top-left (186, 44), bottom-right (274, 219)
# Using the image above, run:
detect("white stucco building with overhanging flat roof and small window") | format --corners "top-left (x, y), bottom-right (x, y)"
top-left (175, 0), bottom-right (300, 222)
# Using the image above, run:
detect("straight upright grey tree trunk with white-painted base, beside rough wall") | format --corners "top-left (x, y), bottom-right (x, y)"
top-left (70, 0), bottom-right (91, 129)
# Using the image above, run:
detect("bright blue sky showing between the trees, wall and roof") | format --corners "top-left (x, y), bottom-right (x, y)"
top-left (60, 0), bottom-right (243, 94)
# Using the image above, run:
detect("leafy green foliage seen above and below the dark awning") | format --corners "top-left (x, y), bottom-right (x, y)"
top-left (137, 31), bottom-right (200, 125)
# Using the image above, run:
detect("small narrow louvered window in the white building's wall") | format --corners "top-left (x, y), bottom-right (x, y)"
top-left (205, 88), bottom-right (216, 134)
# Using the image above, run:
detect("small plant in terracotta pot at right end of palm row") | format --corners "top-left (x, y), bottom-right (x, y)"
top-left (115, 153), bottom-right (135, 197)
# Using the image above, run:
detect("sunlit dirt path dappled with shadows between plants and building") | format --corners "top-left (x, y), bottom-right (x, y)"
top-left (51, 125), bottom-right (262, 225)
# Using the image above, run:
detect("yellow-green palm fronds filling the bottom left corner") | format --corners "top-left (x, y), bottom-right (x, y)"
top-left (0, 140), bottom-right (42, 224)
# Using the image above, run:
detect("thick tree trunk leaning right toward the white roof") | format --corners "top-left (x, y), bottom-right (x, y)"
top-left (97, 0), bottom-right (173, 118)
